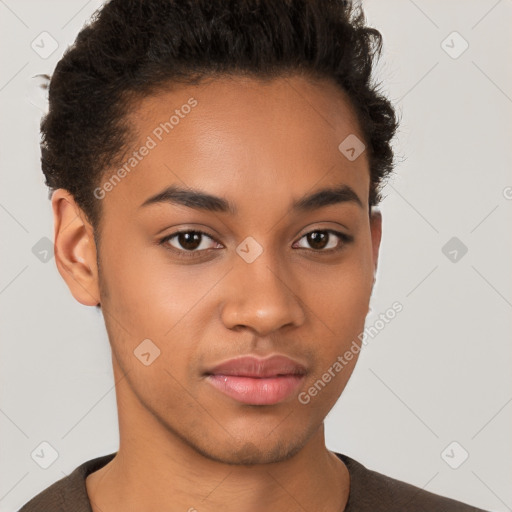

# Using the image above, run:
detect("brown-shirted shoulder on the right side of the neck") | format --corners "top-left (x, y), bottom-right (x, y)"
top-left (336, 453), bottom-right (485, 512)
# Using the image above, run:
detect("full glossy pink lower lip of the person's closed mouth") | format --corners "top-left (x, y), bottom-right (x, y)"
top-left (207, 375), bottom-right (304, 405)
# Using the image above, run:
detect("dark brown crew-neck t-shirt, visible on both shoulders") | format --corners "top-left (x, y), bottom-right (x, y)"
top-left (18, 452), bottom-right (485, 512)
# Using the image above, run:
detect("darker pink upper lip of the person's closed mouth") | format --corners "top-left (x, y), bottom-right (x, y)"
top-left (206, 354), bottom-right (306, 378)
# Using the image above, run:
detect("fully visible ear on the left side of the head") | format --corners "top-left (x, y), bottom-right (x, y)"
top-left (52, 188), bottom-right (100, 306)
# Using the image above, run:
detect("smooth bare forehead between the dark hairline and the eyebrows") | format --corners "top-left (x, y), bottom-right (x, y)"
top-left (104, 76), bottom-right (369, 219)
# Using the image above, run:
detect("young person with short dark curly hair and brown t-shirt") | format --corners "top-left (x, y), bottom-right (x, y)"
top-left (21, 0), bottom-right (488, 512)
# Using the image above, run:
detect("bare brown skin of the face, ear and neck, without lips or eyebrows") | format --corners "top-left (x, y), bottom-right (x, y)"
top-left (52, 76), bottom-right (381, 512)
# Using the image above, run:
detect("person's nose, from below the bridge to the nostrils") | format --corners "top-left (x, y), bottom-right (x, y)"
top-left (221, 251), bottom-right (305, 336)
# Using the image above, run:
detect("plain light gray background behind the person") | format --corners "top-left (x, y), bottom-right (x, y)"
top-left (0, 0), bottom-right (512, 512)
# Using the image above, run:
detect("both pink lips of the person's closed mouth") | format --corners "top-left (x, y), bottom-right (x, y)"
top-left (206, 355), bottom-right (306, 405)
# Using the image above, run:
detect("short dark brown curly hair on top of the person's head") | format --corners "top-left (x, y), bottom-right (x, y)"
top-left (41, 0), bottom-right (398, 236)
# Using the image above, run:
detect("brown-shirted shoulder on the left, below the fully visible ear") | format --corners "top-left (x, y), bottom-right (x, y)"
top-left (18, 453), bottom-right (115, 512)
